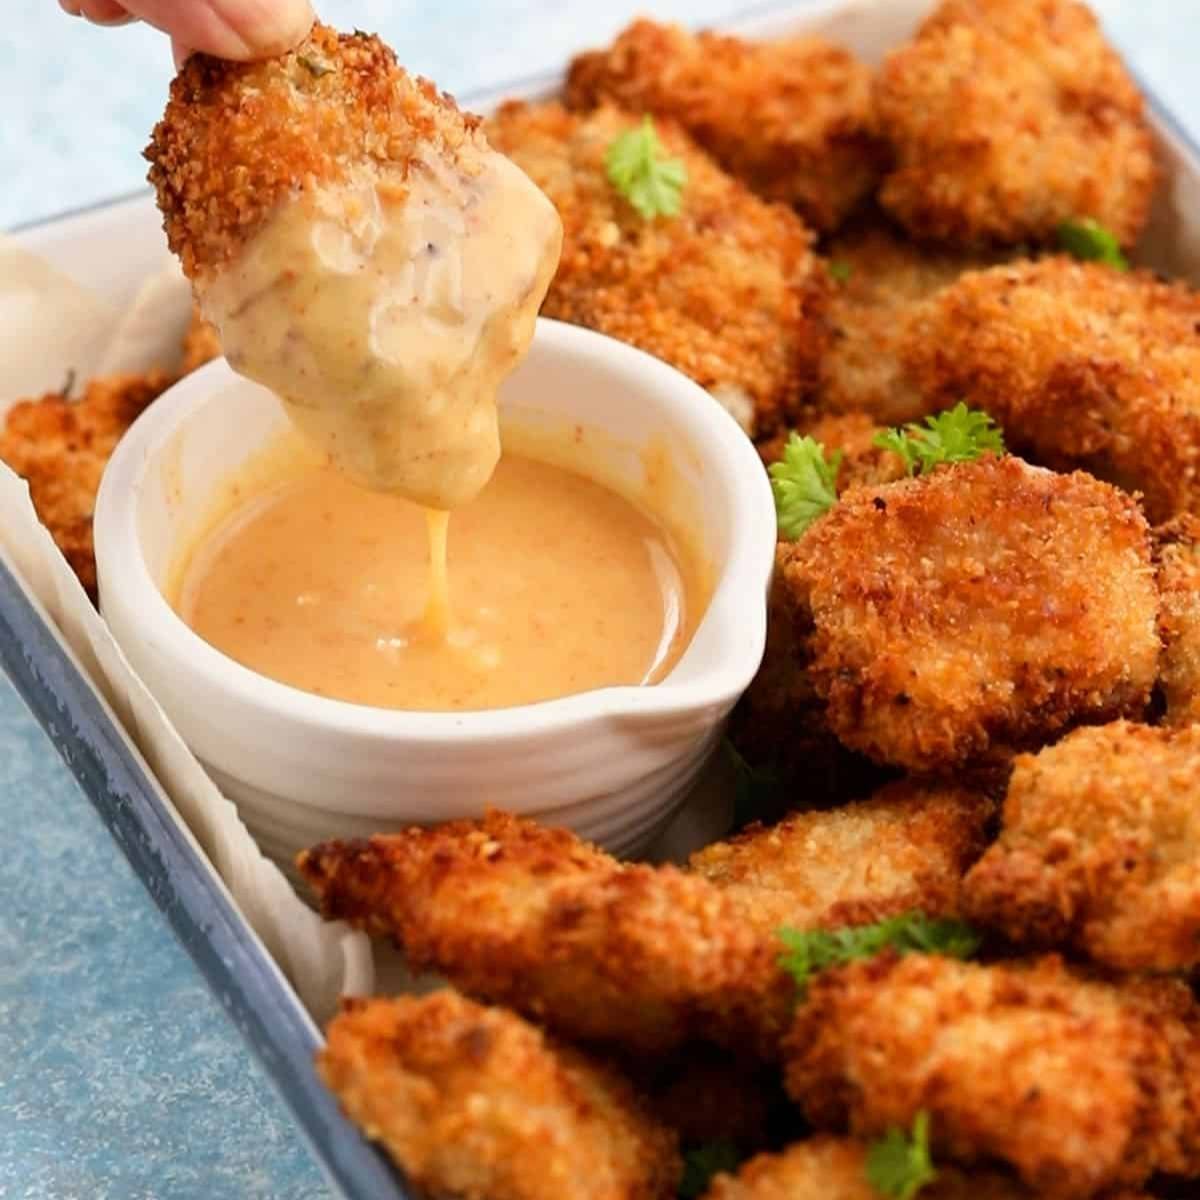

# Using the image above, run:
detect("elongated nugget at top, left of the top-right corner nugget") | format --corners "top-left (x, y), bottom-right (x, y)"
top-left (566, 20), bottom-right (884, 232)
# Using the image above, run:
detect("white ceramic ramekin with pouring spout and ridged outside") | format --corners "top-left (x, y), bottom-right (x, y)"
top-left (95, 320), bottom-right (775, 863)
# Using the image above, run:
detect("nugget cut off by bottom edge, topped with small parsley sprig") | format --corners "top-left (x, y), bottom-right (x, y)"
top-left (704, 1134), bottom-right (1075, 1200)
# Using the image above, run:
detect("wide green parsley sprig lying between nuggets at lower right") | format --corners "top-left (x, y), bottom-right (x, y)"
top-left (776, 910), bottom-right (979, 1000)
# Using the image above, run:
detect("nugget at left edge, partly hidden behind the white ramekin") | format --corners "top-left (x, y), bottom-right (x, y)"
top-left (0, 371), bottom-right (172, 600)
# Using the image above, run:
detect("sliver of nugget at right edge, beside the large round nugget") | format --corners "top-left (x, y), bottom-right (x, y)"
top-left (1154, 512), bottom-right (1200, 725)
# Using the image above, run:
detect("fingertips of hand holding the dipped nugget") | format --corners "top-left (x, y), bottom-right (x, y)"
top-left (59, 0), bottom-right (313, 64)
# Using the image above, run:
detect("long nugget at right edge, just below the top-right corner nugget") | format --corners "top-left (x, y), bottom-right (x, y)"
top-left (904, 258), bottom-right (1200, 522)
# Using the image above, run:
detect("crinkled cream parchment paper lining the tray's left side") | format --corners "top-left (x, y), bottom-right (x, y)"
top-left (0, 234), bottom-right (374, 1022)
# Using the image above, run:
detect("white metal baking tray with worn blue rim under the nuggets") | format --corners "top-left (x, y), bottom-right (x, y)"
top-left (0, 0), bottom-right (1200, 1200)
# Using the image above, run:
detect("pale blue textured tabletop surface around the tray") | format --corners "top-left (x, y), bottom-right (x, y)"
top-left (0, 0), bottom-right (1200, 1200)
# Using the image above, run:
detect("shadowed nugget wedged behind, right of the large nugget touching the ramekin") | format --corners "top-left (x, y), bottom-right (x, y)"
top-left (816, 220), bottom-right (996, 426)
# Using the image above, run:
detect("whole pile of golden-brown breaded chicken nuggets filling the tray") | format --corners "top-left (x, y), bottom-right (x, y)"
top-left (11, 0), bottom-right (1200, 1200)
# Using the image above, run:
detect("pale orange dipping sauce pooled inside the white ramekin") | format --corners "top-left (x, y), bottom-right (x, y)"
top-left (168, 451), bottom-right (708, 712)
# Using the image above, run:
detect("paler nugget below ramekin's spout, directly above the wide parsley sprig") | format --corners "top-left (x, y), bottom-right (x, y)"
top-left (688, 780), bottom-right (992, 937)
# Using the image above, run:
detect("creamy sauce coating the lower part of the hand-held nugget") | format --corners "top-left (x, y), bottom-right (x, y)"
top-left (200, 150), bottom-right (562, 509)
